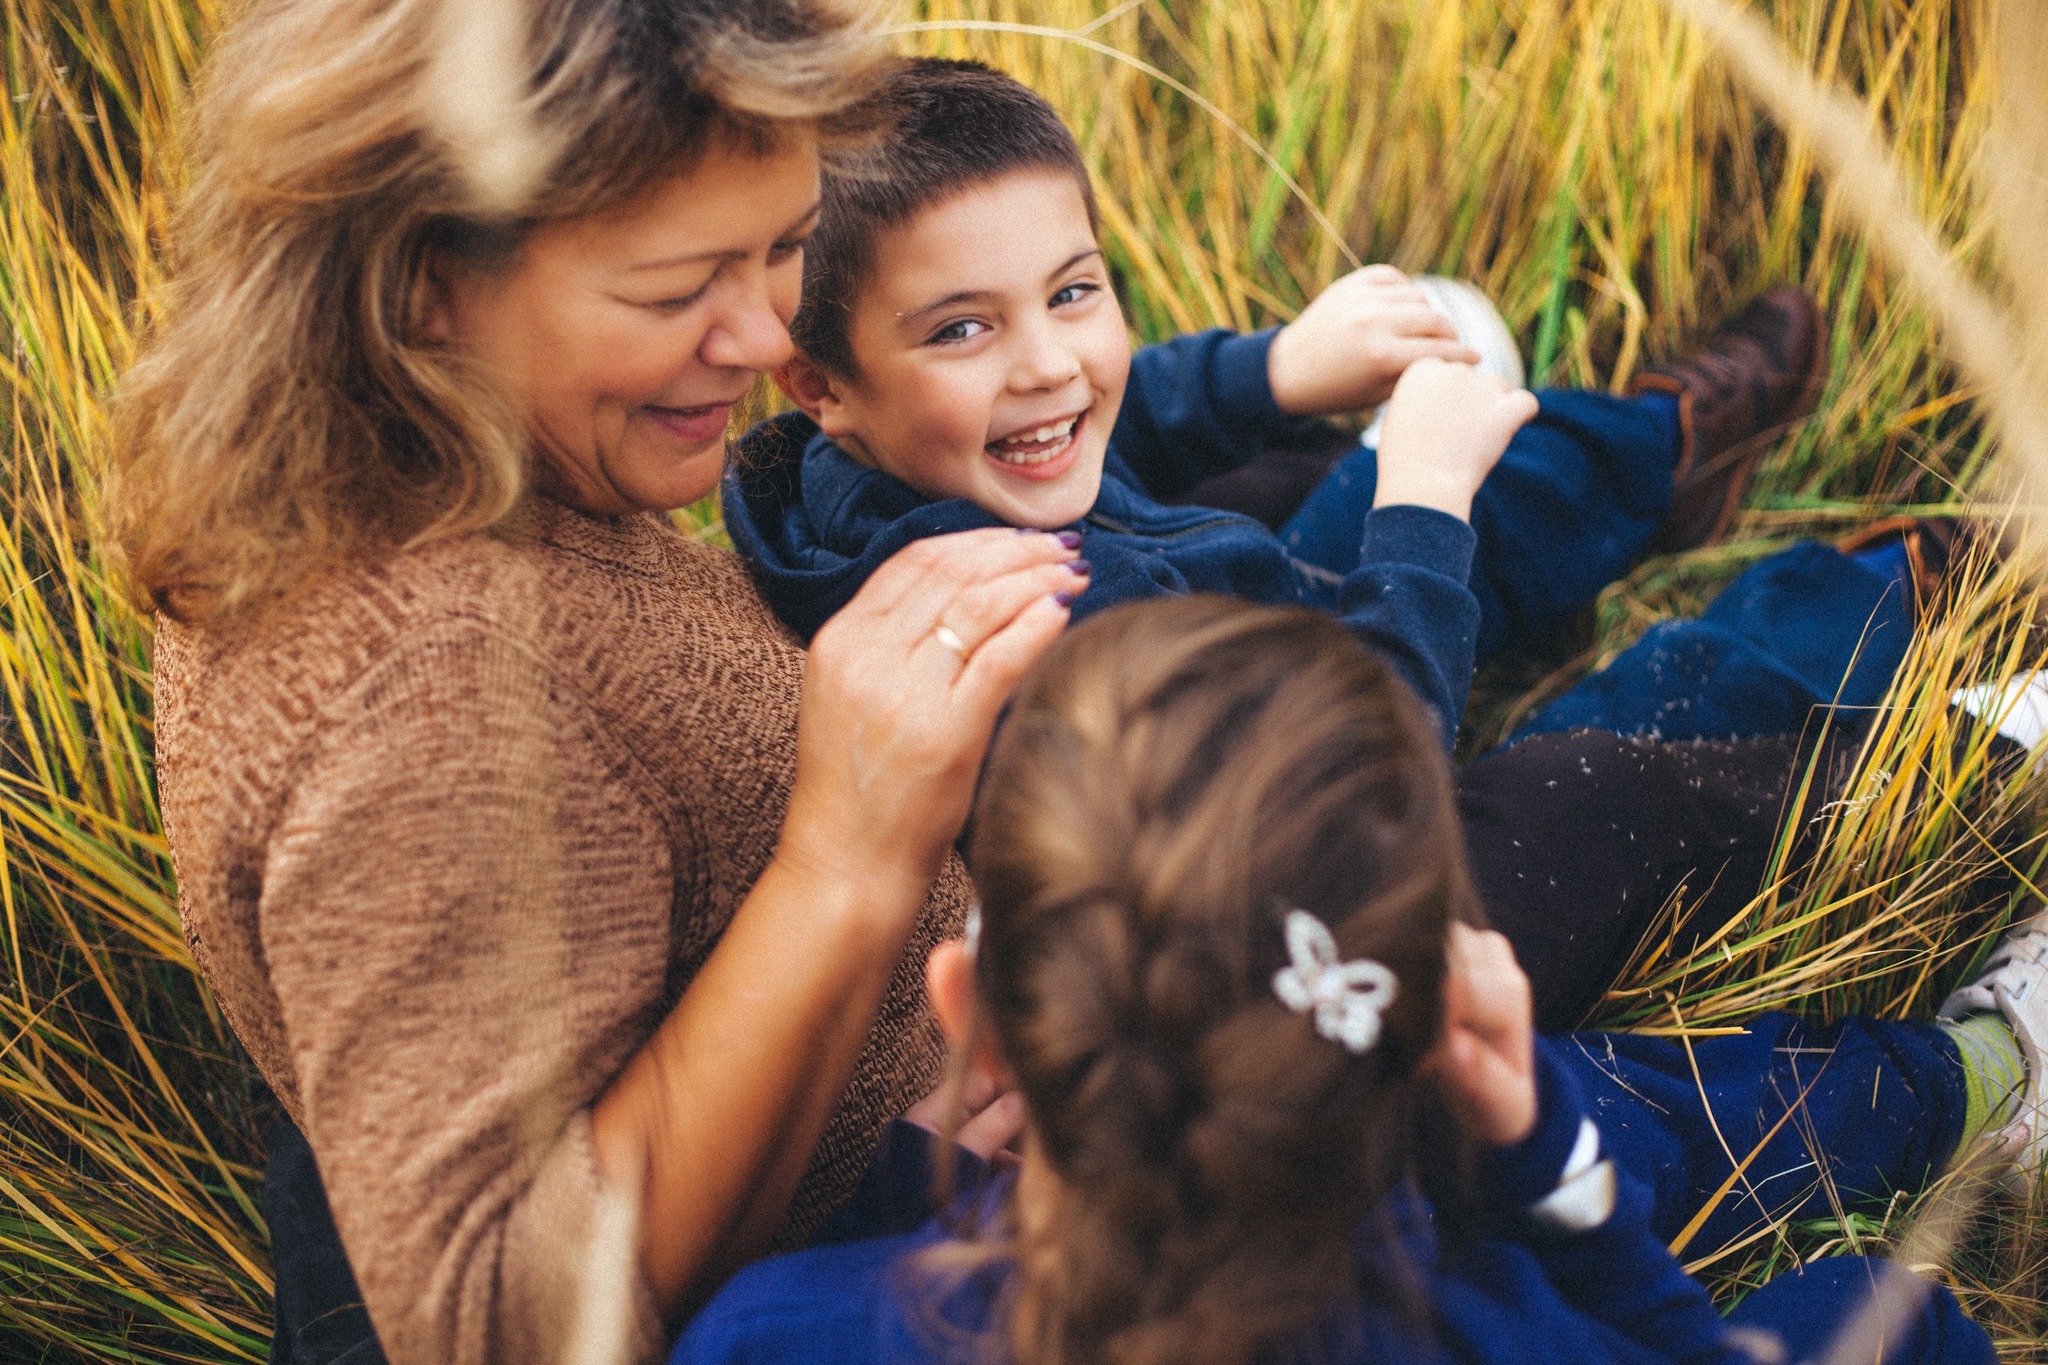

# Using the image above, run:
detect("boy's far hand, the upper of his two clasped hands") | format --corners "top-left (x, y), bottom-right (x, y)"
top-left (1266, 266), bottom-right (1479, 417)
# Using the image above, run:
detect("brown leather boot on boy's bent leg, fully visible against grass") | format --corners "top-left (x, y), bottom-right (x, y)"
top-left (1628, 284), bottom-right (1827, 555)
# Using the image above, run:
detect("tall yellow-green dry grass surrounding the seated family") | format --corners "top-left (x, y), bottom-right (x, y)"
top-left (0, 0), bottom-right (2044, 1361)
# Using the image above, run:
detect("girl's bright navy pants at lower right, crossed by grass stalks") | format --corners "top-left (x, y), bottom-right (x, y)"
top-left (1559, 1013), bottom-right (1997, 1365)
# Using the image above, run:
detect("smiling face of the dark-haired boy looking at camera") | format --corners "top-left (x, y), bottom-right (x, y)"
top-left (805, 170), bottom-right (1130, 530)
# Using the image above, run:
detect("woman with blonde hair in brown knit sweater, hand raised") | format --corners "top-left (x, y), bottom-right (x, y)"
top-left (111, 0), bottom-right (1085, 1365)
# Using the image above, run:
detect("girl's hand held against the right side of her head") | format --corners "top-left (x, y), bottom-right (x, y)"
top-left (1430, 923), bottom-right (1536, 1146)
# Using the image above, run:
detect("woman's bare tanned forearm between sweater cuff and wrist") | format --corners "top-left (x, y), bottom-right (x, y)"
top-left (592, 857), bottom-right (928, 1312)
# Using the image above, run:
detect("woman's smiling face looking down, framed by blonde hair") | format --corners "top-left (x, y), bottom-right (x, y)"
top-left (428, 141), bottom-right (817, 516)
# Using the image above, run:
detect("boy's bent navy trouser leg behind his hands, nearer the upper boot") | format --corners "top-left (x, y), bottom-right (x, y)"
top-left (1280, 389), bottom-right (1679, 661)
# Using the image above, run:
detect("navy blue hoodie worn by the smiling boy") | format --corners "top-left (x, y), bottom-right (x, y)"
top-left (725, 329), bottom-right (1479, 747)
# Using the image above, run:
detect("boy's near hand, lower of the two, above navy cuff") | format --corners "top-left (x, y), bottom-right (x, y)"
top-left (1372, 360), bottom-right (1536, 520)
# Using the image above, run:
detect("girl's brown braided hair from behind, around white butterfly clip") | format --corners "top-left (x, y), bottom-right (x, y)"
top-left (973, 598), bottom-right (1470, 1361)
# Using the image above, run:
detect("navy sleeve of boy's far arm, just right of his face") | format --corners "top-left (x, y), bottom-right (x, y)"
top-left (1110, 327), bottom-right (1303, 501)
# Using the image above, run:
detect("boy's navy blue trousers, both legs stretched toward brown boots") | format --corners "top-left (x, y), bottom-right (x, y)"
top-left (1280, 389), bottom-right (1913, 739)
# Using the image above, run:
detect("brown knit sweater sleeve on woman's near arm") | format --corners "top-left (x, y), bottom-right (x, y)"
top-left (258, 624), bottom-right (674, 1365)
